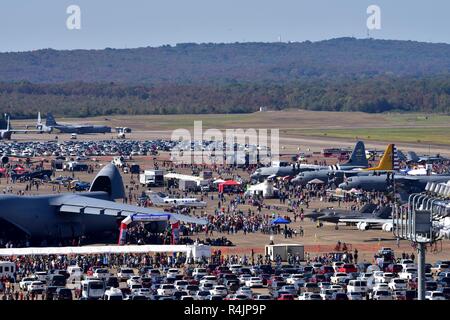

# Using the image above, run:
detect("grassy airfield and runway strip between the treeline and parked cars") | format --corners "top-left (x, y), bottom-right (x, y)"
top-left (13, 110), bottom-right (450, 156)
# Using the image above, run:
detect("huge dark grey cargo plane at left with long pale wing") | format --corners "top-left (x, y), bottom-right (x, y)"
top-left (0, 164), bottom-right (207, 239)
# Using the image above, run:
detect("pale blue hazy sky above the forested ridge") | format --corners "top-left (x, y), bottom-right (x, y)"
top-left (0, 0), bottom-right (450, 52)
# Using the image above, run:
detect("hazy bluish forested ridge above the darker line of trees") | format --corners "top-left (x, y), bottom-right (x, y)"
top-left (0, 38), bottom-right (450, 85)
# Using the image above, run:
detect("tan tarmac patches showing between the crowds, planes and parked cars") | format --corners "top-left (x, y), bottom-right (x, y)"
top-left (4, 152), bottom-right (450, 262)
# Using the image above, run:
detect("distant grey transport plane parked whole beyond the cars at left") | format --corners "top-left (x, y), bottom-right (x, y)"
top-left (36, 112), bottom-right (111, 134)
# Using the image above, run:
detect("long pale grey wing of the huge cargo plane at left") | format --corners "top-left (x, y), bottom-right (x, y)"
top-left (50, 194), bottom-right (208, 224)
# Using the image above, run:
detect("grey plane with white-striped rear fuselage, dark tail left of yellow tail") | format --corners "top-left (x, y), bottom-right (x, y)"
top-left (251, 141), bottom-right (369, 181)
